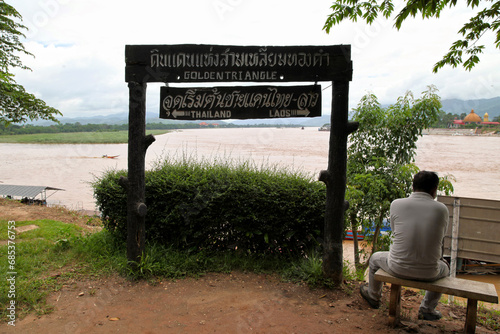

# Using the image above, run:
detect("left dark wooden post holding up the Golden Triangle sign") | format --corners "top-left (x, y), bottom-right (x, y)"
top-left (126, 82), bottom-right (155, 265)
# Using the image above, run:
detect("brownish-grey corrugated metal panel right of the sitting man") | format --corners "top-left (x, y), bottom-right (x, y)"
top-left (438, 196), bottom-right (500, 263)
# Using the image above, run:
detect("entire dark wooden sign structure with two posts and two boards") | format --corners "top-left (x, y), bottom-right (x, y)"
top-left (121, 44), bottom-right (357, 283)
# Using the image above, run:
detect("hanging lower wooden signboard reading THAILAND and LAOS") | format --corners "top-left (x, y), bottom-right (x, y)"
top-left (160, 85), bottom-right (321, 120)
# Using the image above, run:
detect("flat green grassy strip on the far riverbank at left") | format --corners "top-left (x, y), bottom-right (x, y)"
top-left (0, 130), bottom-right (169, 144)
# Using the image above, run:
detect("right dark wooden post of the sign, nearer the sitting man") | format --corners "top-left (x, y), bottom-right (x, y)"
top-left (319, 81), bottom-right (358, 285)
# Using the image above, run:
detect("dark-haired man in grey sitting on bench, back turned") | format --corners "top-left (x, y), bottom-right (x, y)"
top-left (360, 171), bottom-right (450, 320)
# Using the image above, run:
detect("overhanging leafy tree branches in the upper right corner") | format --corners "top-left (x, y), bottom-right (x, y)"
top-left (323, 0), bottom-right (500, 72)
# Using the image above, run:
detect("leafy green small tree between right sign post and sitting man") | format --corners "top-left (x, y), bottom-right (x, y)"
top-left (346, 86), bottom-right (452, 267)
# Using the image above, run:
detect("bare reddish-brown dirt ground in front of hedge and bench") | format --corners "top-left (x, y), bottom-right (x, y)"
top-left (0, 199), bottom-right (495, 334)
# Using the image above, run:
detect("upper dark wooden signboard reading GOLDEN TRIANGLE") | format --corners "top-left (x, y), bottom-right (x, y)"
top-left (125, 44), bottom-right (352, 83)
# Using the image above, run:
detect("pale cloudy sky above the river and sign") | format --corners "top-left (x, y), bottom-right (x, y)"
top-left (7, 0), bottom-right (500, 117)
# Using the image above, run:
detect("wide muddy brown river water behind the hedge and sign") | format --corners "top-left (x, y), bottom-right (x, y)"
top-left (0, 128), bottom-right (500, 306)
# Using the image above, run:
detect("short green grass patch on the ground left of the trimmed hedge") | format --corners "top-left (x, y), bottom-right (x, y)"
top-left (0, 220), bottom-right (127, 321)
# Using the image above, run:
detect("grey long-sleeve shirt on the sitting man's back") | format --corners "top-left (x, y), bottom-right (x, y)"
top-left (388, 192), bottom-right (449, 279)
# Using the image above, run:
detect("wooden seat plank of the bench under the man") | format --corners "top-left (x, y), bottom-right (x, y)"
top-left (375, 269), bottom-right (498, 304)
